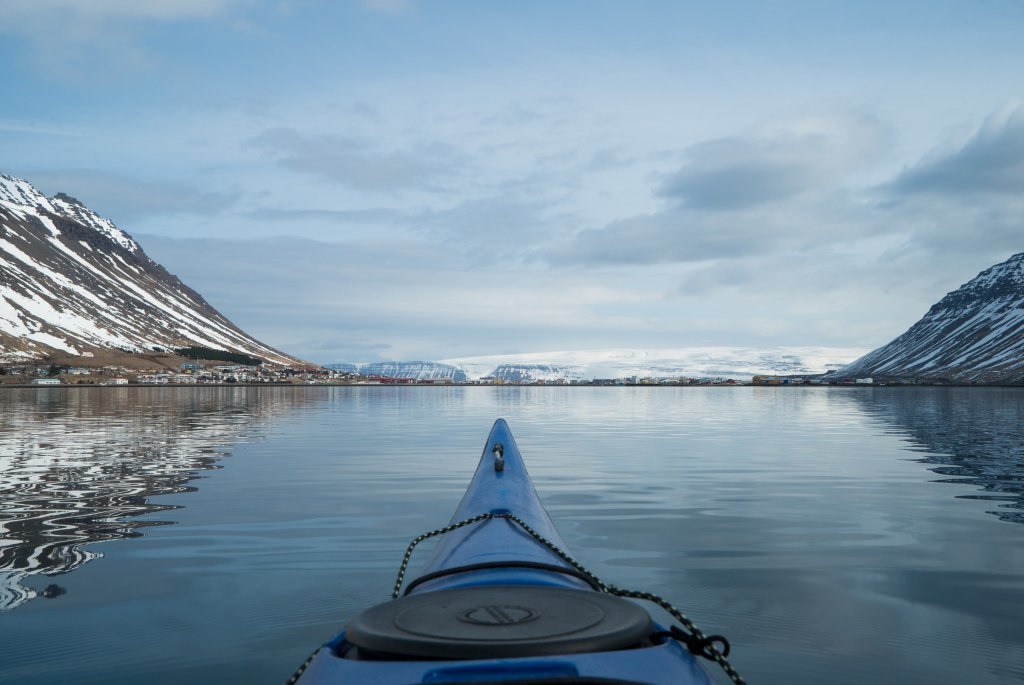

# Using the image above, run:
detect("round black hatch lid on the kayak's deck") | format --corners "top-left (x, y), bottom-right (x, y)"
top-left (345, 586), bottom-right (653, 659)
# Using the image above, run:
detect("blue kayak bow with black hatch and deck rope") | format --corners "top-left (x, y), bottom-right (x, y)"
top-left (289, 419), bottom-right (742, 685)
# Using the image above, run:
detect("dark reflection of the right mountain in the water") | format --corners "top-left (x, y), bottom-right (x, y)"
top-left (855, 388), bottom-right (1024, 523)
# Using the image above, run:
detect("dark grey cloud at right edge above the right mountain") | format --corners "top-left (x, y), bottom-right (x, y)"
top-left (882, 102), bottom-right (1024, 197)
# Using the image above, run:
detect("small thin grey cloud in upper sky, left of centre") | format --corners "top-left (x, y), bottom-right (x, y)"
top-left (249, 127), bottom-right (467, 192)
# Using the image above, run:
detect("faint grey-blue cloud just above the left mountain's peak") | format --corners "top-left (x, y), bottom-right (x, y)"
top-left (26, 169), bottom-right (239, 225)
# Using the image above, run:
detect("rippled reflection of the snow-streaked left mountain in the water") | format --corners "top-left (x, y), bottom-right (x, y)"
top-left (0, 388), bottom-right (318, 610)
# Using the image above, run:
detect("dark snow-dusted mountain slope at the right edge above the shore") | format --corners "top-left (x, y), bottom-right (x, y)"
top-left (839, 253), bottom-right (1024, 384)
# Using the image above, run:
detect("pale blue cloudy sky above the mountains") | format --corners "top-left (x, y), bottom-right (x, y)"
top-left (0, 0), bottom-right (1024, 363)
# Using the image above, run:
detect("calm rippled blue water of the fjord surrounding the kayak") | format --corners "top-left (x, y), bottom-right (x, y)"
top-left (0, 387), bottom-right (1024, 685)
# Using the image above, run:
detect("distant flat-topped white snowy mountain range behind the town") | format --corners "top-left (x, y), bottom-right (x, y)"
top-left (328, 347), bottom-right (865, 383)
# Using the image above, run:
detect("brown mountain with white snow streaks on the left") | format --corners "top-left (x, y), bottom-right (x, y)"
top-left (0, 174), bottom-right (300, 365)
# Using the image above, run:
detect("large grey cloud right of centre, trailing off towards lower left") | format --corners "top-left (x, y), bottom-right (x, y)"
top-left (542, 113), bottom-right (888, 266)
